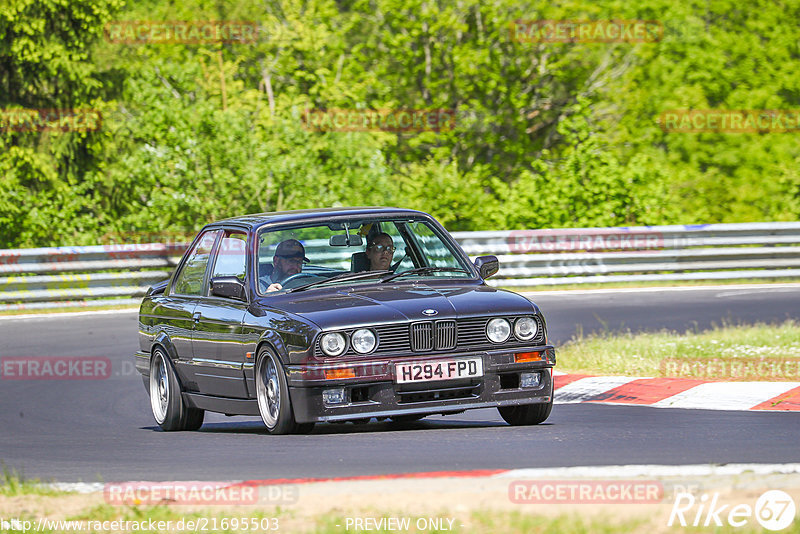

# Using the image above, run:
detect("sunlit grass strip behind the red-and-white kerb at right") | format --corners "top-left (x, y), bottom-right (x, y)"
top-left (557, 321), bottom-right (800, 380)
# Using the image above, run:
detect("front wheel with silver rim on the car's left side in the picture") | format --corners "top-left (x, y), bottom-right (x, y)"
top-left (256, 347), bottom-right (304, 434)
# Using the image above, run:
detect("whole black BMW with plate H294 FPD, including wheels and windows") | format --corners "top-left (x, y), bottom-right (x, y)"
top-left (135, 207), bottom-right (555, 434)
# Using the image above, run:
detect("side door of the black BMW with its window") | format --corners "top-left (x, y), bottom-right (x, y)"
top-left (192, 229), bottom-right (248, 398)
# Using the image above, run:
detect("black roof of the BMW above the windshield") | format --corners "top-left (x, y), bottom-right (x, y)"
top-left (207, 206), bottom-right (431, 230)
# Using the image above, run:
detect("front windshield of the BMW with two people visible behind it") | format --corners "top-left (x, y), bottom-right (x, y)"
top-left (256, 218), bottom-right (474, 295)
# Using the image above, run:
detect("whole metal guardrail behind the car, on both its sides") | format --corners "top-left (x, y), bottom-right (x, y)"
top-left (0, 222), bottom-right (800, 309)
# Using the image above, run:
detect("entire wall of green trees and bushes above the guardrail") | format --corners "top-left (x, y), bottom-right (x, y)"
top-left (0, 0), bottom-right (800, 247)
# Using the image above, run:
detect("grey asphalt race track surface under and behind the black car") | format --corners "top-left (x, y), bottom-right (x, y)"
top-left (0, 286), bottom-right (800, 482)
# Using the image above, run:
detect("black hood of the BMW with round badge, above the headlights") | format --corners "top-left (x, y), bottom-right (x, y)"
top-left (268, 283), bottom-right (536, 330)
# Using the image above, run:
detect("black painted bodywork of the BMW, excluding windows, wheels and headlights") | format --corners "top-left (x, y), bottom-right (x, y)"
top-left (135, 207), bottom-right (555, 423)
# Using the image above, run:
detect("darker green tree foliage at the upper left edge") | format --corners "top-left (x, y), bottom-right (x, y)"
top-left (0, 0), bottom-right (121, 247)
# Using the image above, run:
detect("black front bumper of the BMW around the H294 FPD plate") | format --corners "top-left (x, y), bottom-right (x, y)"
top-left (287, 345), bottom-right (555, 423)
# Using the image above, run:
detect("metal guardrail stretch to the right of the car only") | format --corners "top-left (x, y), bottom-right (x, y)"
top-left (453, 222), bottom-right (800, 287)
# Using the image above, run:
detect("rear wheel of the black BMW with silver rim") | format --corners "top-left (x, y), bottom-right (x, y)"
top-left (148, 347), bottom-right (205, 432)
